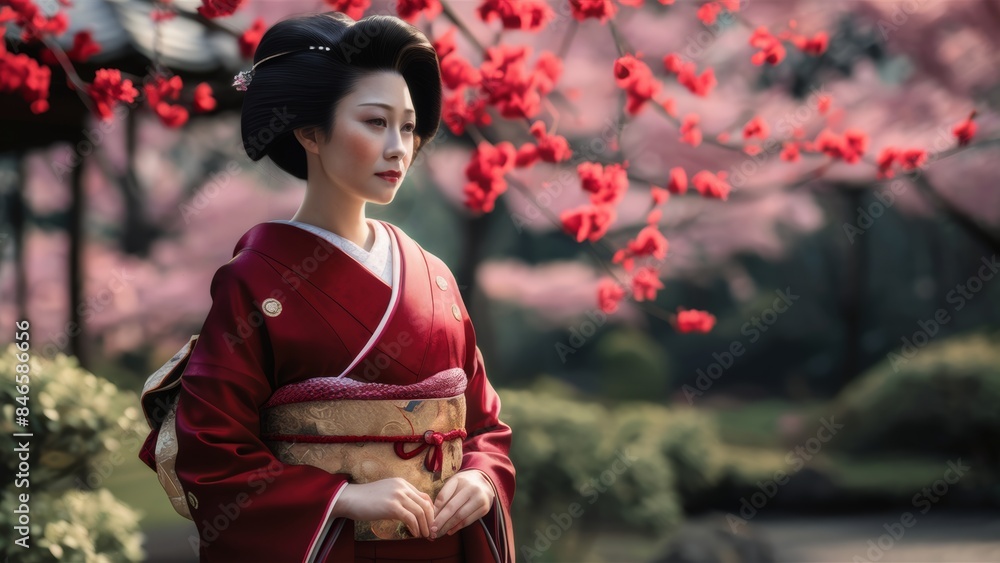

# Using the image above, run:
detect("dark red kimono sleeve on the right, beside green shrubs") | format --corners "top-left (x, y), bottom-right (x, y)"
top-left (459, 301), bottom-right (515, 563)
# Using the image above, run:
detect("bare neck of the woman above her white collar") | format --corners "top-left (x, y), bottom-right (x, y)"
top-left (292, 186), bottom-right (375, 251)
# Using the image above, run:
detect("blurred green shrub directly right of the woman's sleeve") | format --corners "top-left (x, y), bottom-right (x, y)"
top-left (499, 382), bottom-right (728, 561)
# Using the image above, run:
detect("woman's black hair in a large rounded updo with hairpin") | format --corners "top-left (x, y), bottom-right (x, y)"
top-left (240, 12), bottom-right (441, 180)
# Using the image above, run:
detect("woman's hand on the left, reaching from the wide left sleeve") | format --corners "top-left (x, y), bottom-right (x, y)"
top-left (333, 477), bottom-right (434, 538)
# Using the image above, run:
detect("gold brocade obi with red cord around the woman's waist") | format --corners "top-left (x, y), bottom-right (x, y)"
top-left (261, 368), bottom-right (467, 540)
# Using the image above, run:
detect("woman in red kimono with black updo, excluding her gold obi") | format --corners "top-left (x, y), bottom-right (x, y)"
top-left (165, 12), bottom-right (514, 563)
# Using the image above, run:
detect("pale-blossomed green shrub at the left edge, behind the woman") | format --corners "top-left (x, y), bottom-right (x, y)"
top-left (0, 344), bottom-right (145, 563)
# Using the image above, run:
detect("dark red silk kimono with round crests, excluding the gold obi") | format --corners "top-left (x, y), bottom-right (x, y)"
top-left (158, 222), bottom-right (515, 563)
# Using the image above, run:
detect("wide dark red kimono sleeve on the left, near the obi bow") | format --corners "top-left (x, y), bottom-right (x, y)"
top-left (176, 252), bottom-right (348, 562)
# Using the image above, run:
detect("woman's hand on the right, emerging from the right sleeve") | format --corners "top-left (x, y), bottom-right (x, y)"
top-left (431, 470), bottom-right (496, 539)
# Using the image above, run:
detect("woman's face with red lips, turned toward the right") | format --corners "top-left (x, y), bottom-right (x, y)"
top-left (304, 71), bottom-right (416, 204)
